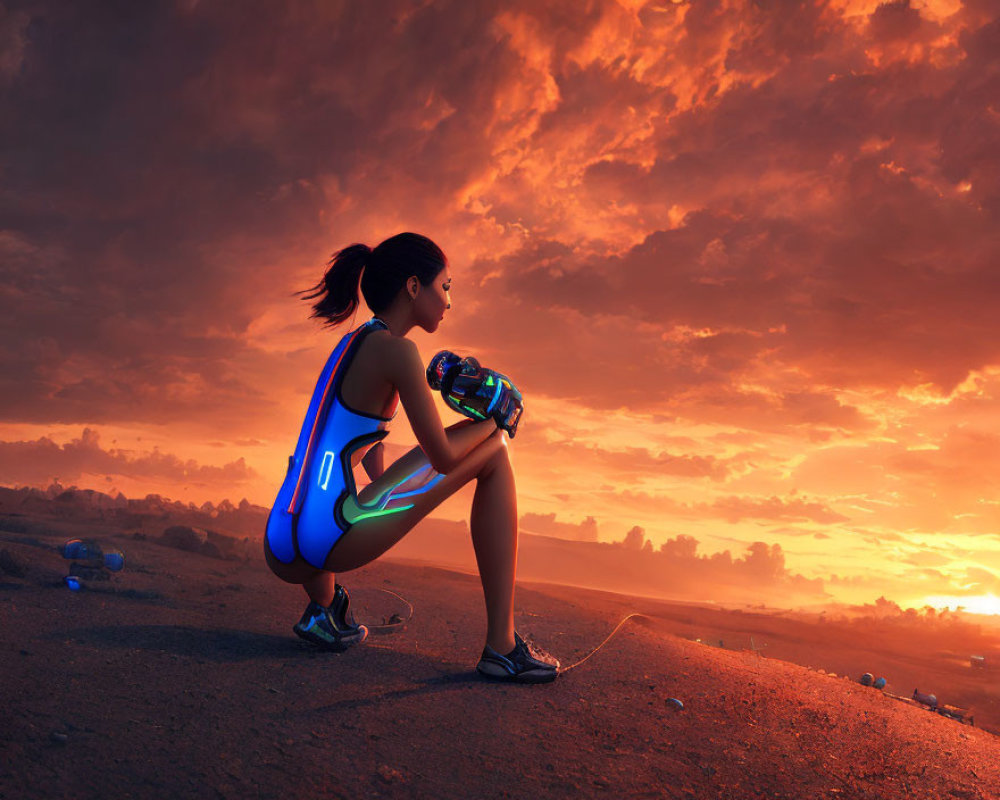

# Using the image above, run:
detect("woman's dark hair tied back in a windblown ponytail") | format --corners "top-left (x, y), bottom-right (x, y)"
top-left (296, 233), bottom-right (448, 327)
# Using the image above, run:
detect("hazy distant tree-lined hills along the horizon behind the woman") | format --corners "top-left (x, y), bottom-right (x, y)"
top-left (0, 483), bottom-right (831, 608)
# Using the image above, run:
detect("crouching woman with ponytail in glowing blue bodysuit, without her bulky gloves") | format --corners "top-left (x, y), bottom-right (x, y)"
top-left (264, 233), bottom-right (559, 683)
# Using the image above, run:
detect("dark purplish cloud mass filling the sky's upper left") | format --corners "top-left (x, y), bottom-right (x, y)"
top-left (0, 2), bottom-right (586, 432)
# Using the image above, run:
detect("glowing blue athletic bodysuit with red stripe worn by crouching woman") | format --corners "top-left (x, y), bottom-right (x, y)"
top-left (265, 317), bottom-right (444, 569)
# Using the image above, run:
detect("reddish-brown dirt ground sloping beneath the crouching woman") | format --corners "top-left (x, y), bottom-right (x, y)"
top-left (0, 521), bottom-right (1000, 800)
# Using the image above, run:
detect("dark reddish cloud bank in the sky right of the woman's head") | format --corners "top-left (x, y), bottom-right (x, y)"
top-left (454, 3), bottom-right (1000, 410)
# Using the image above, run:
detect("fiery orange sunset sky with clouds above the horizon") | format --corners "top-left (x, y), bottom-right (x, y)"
top-left (0, 0), bottom-right (1000, 611)
